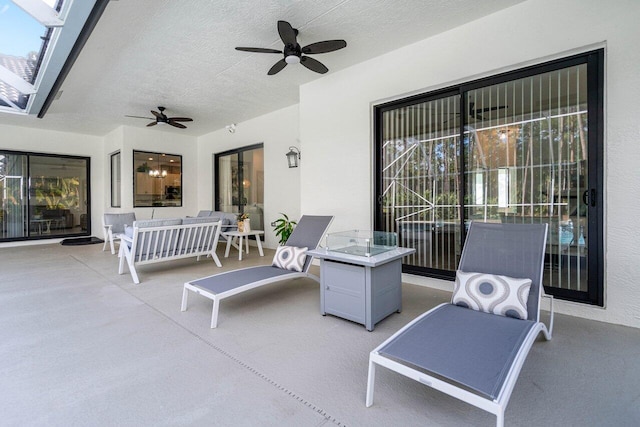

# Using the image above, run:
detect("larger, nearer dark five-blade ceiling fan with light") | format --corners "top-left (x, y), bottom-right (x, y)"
top-left (236, 21), bottom-right (347, 76)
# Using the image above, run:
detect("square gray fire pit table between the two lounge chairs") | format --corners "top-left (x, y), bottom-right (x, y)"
top-left (307, 248), bottom-right (416, 331)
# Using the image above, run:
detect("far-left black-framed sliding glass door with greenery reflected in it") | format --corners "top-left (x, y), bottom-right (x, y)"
top-left (0, 151), bottom-right (91, 241)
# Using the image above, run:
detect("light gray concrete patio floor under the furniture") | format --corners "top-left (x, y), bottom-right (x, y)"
top-left (0, 244), bottom-right (640, 426)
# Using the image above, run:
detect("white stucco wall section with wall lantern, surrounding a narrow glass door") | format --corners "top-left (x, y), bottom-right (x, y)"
top-left (198, 105), bottom-right (302, 248)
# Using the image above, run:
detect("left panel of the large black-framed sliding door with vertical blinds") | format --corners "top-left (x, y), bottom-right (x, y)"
top-left (377, 94), bottom-right (461, 275)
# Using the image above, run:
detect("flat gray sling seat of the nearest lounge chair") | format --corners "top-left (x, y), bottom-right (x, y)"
top-left (380, 304), bottom-right (535, 399)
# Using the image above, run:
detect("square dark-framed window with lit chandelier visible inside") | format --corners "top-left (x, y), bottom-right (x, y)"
top-left (133, 151), bottom-right (182, 208)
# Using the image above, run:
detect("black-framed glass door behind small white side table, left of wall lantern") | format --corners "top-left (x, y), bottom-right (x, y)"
top-left (215, 144), bottom-right (264, 230)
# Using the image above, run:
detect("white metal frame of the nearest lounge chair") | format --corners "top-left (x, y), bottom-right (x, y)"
top-left (366, 224), bottom-right (553, 427)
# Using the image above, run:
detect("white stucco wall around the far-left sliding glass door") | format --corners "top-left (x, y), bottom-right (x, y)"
top-left (0, 124), bottom-right (105, 247)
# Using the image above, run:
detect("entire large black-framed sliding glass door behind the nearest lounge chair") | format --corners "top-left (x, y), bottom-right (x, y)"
top-left (375, 50), bottom-right (603, 305)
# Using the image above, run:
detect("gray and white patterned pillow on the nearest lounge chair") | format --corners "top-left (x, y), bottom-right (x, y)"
top-left (451, 270), bottom-right (531, 319)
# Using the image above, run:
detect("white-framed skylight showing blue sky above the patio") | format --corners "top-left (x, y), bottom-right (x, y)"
top-left (0, 0), bottom-right (109, 118)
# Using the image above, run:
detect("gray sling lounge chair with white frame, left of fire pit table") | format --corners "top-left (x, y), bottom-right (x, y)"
top-left (181, 215), bottom-right (333, 328)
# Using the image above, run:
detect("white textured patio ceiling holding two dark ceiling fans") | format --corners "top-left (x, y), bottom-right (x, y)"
top-left (0, 0), bottom-right (523, 136)
